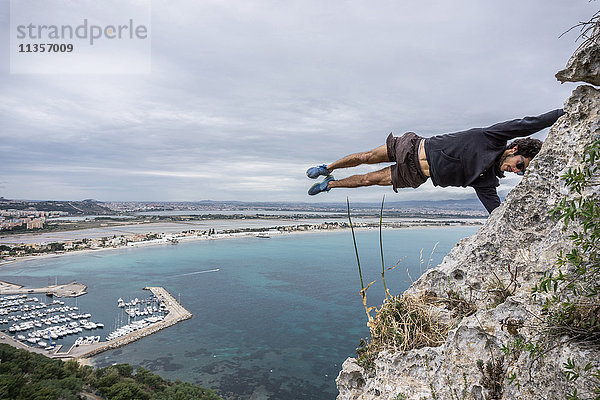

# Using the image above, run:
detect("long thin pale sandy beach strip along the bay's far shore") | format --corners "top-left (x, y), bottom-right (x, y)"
top-left (0, 220), bottom-right (483, 268)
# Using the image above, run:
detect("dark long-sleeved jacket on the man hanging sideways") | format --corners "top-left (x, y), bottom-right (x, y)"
top-left (425, 109), bottom-right (564, 213)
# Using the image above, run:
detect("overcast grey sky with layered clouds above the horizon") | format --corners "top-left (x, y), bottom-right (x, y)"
top-left (0, 0), bottom-right (599, 202)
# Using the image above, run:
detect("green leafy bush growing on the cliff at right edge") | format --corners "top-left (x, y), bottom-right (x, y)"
top-left (533, 140), bottom-right (600, 400)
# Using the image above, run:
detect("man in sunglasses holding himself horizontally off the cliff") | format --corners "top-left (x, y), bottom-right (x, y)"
top-left (306, 109), bottom-right (564, 213)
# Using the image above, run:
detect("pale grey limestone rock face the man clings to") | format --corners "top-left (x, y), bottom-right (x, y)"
top-left (336, 48), bottom-right (600, 400)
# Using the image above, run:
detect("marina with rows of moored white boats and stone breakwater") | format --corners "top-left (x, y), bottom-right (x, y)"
top-left (0, 282), bottom-right (192, 362)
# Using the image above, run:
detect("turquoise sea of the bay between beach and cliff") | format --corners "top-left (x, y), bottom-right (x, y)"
top-left (0, 227), bottom-right (477, 400)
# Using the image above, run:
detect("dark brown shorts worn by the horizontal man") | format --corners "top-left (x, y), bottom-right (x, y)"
top-left (385, 132), bottom-right (427, 192)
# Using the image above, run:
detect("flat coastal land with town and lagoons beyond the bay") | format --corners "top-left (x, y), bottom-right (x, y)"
top-left (0, 198), bottom-right (484, 263)
